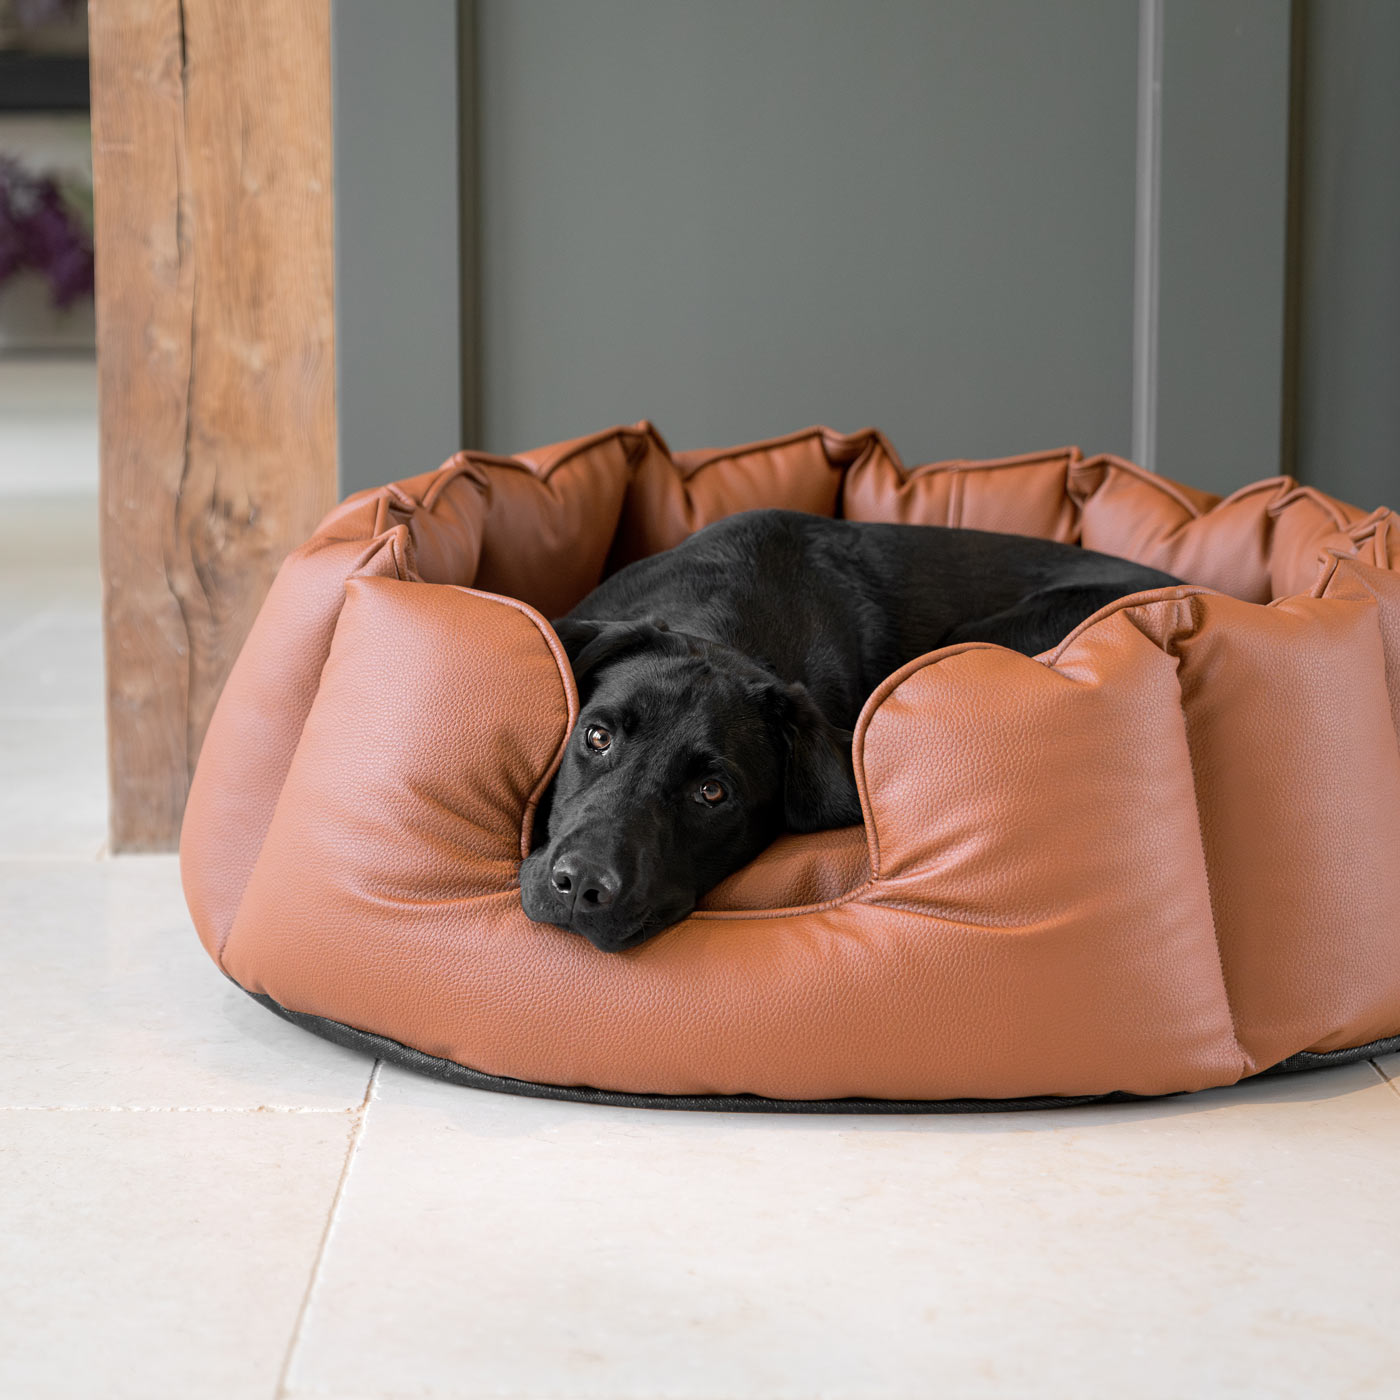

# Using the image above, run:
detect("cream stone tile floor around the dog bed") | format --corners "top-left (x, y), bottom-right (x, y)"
top-left (0, 498), bottom-right (1400, 1400)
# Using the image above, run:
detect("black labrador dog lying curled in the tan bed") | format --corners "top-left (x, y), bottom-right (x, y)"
top-left (521, 510), bottom-right (1179, 952)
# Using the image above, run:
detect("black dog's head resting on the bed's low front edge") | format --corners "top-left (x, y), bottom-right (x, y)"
top-left (521, 619), bottom-right (861, 952)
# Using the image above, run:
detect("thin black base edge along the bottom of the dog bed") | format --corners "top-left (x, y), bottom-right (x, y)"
top-left (243, 991), bottom-right (1400, 1113)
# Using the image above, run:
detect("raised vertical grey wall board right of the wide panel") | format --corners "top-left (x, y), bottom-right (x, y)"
top-left (1148, 0), bottom-right (1289, 491)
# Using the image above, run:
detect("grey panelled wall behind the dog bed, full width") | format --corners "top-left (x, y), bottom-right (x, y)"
top-left (332, 0), bottom-right (1400, 515)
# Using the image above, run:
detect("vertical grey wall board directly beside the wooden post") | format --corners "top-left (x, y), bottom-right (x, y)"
top-left (330, 0), bottom-right (463, 493)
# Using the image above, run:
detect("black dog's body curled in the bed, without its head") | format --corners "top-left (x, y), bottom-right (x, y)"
top-left (570, 510), bottom-right (1177, 728)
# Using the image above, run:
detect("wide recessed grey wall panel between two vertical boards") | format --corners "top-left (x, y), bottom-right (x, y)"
top-left (477, 0), bottom-right (1137, 461)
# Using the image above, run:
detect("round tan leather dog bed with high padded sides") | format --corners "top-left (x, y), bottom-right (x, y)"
top-left (181, 423), bottom-right (1400, 1112)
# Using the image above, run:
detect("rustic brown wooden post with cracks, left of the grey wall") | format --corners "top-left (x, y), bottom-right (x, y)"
top-left (90, 0), bottom-right (336, 851)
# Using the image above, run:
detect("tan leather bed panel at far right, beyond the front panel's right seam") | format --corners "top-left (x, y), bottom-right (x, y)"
top-left (1128, 594), bottom-right (1400, 1065)
